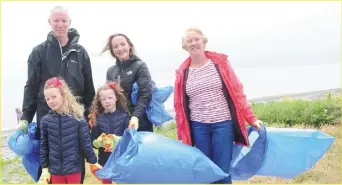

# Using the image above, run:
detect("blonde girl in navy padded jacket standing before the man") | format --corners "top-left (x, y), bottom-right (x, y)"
top-left (40, 77), bottom-right (101, 184)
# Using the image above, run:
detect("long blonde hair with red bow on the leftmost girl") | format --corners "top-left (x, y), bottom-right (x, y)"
top-left (44, 77), bottom-right (84, 120)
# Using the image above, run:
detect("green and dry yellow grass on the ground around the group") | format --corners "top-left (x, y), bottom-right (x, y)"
top-left (0, 95), bottom-right (341, 184)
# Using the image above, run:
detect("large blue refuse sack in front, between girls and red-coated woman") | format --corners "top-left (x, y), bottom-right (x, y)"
top-left (96, 129), bottom-right (228, 184)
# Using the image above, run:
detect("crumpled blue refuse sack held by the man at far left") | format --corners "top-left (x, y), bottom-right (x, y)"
top-left (8, 122), bottom-right (40, 182)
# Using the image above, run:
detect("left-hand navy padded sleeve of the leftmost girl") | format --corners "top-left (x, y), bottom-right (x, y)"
top-left (40, 117), bottom-right (49, 168)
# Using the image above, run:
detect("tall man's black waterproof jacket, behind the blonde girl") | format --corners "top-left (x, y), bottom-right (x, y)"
top-left (21, 28), bottom-right (95, 126)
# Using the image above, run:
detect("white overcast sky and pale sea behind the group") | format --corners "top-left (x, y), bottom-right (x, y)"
top-left (1, 1), bottom-right (341, 129)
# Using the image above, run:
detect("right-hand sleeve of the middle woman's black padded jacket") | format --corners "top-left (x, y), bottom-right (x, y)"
top-left (132, 63), bottom-right (152, 117)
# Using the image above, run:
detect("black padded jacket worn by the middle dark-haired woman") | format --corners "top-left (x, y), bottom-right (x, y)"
top-left (106, 55), bottom-right (152, 129)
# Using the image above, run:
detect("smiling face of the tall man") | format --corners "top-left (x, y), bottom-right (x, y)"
top-left (49, 10), bottom-right (70, 38)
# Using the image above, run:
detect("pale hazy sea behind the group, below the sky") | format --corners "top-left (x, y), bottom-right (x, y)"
top-left (1, 62), bottom-right (341, 131)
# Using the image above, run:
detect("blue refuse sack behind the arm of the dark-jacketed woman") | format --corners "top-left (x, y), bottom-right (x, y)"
top-left (131, 81), bottom-right (173, 126)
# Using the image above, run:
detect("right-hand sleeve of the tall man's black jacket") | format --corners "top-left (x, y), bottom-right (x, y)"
top-left (83, 49), bottom-right (95, 119)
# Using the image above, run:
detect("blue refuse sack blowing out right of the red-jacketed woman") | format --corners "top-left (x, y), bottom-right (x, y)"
top-left (231, 124), bottom-right (335, 180)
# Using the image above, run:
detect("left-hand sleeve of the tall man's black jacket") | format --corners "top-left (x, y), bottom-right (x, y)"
top-left (20, 49), bottom-right (41, 123)
